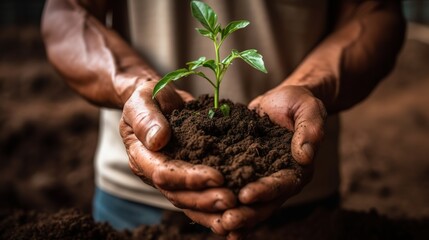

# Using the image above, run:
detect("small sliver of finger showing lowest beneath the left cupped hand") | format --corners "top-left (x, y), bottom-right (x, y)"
top-left (183, 209), bottom-right (228, 235)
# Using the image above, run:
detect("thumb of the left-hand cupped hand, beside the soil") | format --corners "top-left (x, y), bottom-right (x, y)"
top-left (122, 85), bottom-right (171, 151)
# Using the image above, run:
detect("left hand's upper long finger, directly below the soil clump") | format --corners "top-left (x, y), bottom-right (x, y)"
top-left (152, 160), bottom-right (224, 190)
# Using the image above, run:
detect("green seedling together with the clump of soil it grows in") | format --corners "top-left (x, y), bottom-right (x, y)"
top-left (149, 1), bottom-right (301, 194)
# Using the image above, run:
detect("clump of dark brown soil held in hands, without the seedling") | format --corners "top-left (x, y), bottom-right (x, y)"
top-left (162, 95), bottom-right (300, 193)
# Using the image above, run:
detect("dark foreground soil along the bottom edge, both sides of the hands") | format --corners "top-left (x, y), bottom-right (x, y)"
top-left (0, 208), bottom-right (429, 240)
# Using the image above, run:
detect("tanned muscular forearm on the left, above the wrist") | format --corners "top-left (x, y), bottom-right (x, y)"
top-left (42, 0), bottom-right (159, 108)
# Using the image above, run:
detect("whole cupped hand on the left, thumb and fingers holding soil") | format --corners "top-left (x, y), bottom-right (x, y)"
top-left (120, 81), bottom-right (236, 219)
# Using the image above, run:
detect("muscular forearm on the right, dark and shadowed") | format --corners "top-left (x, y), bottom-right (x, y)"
top-left (283, 1), bottom-right (405, 113)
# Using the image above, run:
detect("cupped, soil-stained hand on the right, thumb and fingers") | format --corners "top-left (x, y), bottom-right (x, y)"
top-left (216, 86), bottom-right (327, 239)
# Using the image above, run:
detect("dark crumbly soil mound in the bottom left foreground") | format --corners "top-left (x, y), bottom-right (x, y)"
top-left (0, 209), bottom-right (219, 240)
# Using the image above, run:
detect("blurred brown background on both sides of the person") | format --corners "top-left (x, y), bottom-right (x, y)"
top-left (0, 0), bottom-right (429, 218)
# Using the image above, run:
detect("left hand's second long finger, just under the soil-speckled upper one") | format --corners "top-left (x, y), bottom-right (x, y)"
top-left (160, 188), bottom-right (236, 212)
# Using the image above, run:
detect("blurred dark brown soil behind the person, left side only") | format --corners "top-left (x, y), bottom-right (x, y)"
top-left (0, 26), bottom-right (98, 212)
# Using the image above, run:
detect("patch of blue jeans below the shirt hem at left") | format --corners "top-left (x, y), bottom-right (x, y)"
top-left (92, 188), bottom-right (164, 230)
